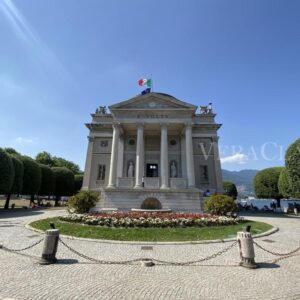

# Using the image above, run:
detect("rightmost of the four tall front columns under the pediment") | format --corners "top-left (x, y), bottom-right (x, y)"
top-left (185, 124), bottom-right (195, 188)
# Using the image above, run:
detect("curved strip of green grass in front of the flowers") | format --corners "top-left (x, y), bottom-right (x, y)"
top-left (30, 218), bottom-right (272, 242)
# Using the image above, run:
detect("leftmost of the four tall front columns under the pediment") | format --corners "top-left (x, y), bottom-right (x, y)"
top-left (107, 124), bottom-right (120, 188)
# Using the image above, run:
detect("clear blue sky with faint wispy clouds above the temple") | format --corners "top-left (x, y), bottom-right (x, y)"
top-left (0, 0), bottom-right (300, 170)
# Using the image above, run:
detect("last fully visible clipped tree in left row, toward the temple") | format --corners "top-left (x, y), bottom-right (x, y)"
top-left (52, 167), bottom-right (74, 206)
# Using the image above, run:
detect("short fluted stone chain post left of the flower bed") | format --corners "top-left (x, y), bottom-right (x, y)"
top-left (39, 229), bottom-right (59, 265)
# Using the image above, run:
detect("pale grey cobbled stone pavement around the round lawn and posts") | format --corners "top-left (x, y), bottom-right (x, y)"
top-left (0, 210), bottom-right (300, 300)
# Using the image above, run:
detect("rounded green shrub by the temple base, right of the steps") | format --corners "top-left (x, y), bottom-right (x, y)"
top-left (205, 195), bottom-right (236, 216)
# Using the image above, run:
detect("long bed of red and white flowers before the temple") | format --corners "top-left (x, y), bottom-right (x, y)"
top-left (59, 212), bottom-right (243, 228)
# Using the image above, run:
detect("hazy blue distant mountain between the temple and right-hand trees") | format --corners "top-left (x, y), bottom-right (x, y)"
top-left (222, 170), bottom-right (258, 194)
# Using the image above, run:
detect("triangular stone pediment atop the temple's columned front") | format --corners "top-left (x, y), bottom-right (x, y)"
top-left (109, 93), bottom-right (197, 111)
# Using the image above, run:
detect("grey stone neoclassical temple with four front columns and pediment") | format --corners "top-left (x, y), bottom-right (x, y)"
top-left (83, 92), bottom-right (223, 211)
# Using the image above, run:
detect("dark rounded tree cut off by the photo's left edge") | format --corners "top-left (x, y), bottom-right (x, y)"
top-left (0, 148), bottom-right (15, 194)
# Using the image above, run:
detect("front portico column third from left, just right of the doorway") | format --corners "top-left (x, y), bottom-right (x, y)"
top-left (160, 124), bottom-right (169, 189)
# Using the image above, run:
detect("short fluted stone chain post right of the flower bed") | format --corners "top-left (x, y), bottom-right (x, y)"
top-left (237, 231), bottom-right (257, 269)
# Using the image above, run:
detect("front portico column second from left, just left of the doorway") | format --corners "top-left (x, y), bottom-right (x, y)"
top-left (135, 124), bottom-right (144, 188)
